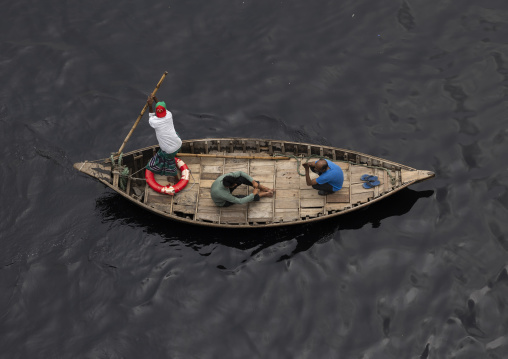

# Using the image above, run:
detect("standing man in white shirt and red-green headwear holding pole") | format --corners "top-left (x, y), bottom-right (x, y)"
top-left (146, 96), bottom-right (182, 184)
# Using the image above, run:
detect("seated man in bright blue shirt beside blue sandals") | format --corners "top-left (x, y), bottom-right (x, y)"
top-left (303, 159), bottom-right (344, 196)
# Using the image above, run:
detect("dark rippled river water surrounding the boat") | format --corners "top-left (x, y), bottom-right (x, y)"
top-left (0, 0), bottom-right (508, 359)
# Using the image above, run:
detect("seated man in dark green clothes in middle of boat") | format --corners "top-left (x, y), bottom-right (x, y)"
top-left (211, 171), bottom-right (273, 207)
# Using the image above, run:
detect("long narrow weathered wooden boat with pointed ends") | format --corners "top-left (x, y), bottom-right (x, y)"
top-left (74, 138), bottom-right (434, 228)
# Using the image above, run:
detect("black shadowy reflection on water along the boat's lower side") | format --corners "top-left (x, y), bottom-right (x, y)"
top-left (96, 188), bottom-right (434, 259)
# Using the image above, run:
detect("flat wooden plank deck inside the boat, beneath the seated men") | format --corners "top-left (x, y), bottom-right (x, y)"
top-left (145, 157), bottom-right (404, 225)
